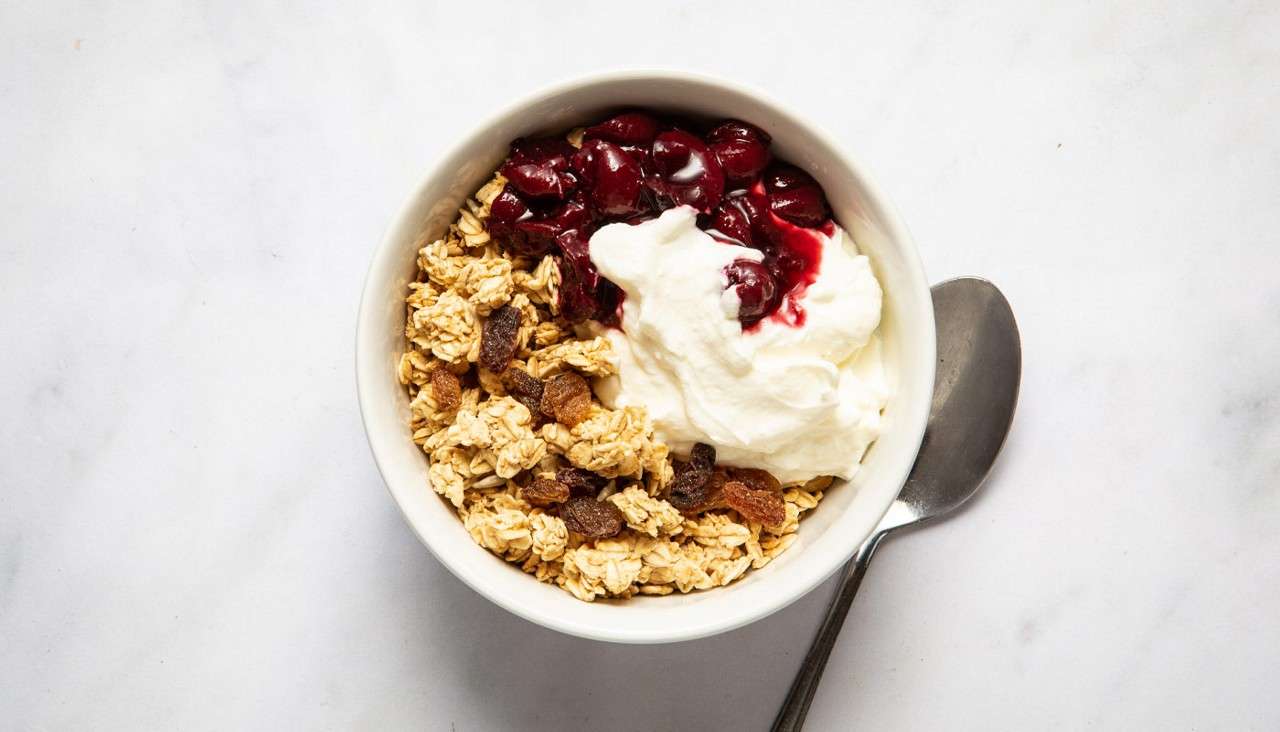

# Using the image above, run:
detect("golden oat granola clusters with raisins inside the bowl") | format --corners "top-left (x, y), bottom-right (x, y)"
top-left (398, 174), bottom-right (831, 601)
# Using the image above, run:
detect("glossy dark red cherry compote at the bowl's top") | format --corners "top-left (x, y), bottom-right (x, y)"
top-left (489, 111), bottom-right (835, 330)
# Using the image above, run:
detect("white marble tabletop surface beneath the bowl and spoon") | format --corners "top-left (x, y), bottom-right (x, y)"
top-left (0, 1), bottom-right (1280, 731)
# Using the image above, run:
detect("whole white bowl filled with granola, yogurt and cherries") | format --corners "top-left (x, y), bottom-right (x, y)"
top-left (356, 72), bottom-right (934, 642)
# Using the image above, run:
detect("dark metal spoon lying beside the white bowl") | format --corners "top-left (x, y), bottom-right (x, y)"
top-left (773, 278), bottom-right (1023, 732)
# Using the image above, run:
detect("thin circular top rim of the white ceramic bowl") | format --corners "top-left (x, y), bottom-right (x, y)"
top-left (355, 68), bottom-right (936, 644)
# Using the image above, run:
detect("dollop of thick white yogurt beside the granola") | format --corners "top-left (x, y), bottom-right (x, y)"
top-left (589, 206), bottom-right (890, 482)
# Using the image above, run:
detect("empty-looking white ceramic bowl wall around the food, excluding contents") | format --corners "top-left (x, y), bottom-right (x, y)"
top-left (356, 72), bottom-right (934, 642)
